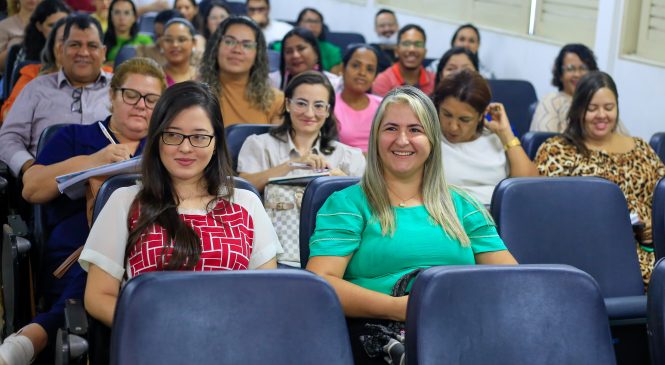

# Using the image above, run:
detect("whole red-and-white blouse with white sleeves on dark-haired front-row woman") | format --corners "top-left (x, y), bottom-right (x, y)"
top-left (79, 186), bottom-right (283, 280)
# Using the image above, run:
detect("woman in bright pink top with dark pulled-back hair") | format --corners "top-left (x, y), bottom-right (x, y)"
top-left (335, 44), bottom-right (381, 153)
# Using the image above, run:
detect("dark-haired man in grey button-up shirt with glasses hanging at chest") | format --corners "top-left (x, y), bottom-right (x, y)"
top-left (0, 14), bottom-right (112, 176)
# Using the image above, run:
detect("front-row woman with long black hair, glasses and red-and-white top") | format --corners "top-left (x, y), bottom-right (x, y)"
top-left (79, 81), bottom-right (281, 326)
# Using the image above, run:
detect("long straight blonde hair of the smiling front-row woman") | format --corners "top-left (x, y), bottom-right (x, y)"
top-left (360, 86), bottom-right (470, 247)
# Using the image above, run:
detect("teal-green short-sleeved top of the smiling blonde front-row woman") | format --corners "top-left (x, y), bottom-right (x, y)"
top-left (310, 185), bottom-right (506, 295)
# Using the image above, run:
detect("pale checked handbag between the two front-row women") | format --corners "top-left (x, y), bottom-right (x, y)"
top-left (263, 184), bottom-right (305, 263)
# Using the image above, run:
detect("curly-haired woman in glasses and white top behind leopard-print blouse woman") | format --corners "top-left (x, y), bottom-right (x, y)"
top-left (530, 43), bottom-right (628, 135)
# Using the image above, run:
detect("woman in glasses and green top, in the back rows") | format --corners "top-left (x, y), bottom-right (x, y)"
top-left (273, 8), bottom-right (342, 75)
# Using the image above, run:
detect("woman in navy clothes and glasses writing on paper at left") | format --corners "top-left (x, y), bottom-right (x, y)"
top-left (0, 58), bottom-right (166, 364)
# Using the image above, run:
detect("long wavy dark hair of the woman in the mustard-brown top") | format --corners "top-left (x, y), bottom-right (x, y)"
top-left (199, 15), bottom-right (276, 112)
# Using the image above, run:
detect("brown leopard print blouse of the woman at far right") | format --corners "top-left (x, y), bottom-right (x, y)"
top-left (535, 136), bottom-right (665, 284)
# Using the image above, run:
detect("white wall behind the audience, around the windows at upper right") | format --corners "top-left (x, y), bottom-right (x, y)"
top-left (271, 0), bottom-right (665, 139)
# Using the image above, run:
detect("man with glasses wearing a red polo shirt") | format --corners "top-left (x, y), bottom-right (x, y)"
top-left (372, 24), bottom-right (435, 96)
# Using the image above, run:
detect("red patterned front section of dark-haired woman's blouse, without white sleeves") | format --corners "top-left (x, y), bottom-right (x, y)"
top-left (128, 200), bottom-right (254, 276)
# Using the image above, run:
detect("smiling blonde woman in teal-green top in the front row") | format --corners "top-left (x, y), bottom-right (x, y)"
top-left (307, 86), bottom-right (517, 364)
